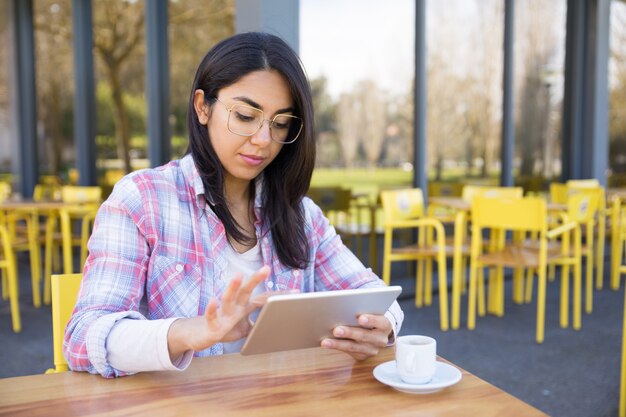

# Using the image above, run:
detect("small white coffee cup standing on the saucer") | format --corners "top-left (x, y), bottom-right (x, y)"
top-left (396, 335), bottom-right (437, 384)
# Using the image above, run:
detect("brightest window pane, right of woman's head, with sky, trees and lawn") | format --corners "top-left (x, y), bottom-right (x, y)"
top-left (300, 0), bottom-right (415, 194)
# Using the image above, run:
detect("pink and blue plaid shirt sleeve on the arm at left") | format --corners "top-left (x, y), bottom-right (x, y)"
top-left (63, 178), bottom-right (155, 378)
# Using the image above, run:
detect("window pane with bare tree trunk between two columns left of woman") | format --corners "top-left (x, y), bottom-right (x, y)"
top-left (93, 0), bottom-right (149, 182)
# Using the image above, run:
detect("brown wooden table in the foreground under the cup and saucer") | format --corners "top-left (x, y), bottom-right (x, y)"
top-left (0, 348), bottom-right (545, 417)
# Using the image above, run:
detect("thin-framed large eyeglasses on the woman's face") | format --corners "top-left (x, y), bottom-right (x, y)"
top-left (215, 98), bottom-right (303, 144)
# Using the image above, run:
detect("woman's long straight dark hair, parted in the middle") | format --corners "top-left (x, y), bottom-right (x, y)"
top-left (187, 32), bottom-right (315, 268)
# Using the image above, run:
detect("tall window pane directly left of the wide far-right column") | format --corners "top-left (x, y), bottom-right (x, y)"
top-left (514, 0), bottom-right (567, 191)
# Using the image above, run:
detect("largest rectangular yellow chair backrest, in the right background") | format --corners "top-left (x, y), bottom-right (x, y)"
top-left (472, 196), bottom-right (547, 232)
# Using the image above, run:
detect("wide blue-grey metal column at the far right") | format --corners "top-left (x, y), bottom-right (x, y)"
top-left (561, 0), bottom-right (610, 185)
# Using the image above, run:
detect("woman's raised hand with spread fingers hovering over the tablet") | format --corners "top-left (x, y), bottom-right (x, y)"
top-left (167, 265), bottom-right (270, 361)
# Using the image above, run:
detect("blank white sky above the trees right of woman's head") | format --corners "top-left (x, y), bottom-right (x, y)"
top-left (300, 0), bottom-right (415, 98)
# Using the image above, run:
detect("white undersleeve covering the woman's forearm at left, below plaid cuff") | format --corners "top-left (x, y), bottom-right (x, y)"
top-left (106, 318), bottom-right (193, 374)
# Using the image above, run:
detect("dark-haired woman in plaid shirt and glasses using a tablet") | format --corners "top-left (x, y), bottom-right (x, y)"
top-left (64, 33), bottom-right (403, 377)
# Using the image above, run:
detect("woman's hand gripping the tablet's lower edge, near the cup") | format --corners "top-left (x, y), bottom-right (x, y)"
top-left (322, 314), bottom-right (393, 360)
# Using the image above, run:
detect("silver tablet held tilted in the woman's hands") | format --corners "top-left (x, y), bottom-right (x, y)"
top-left (241, 286), bottom-right (402, 355)
